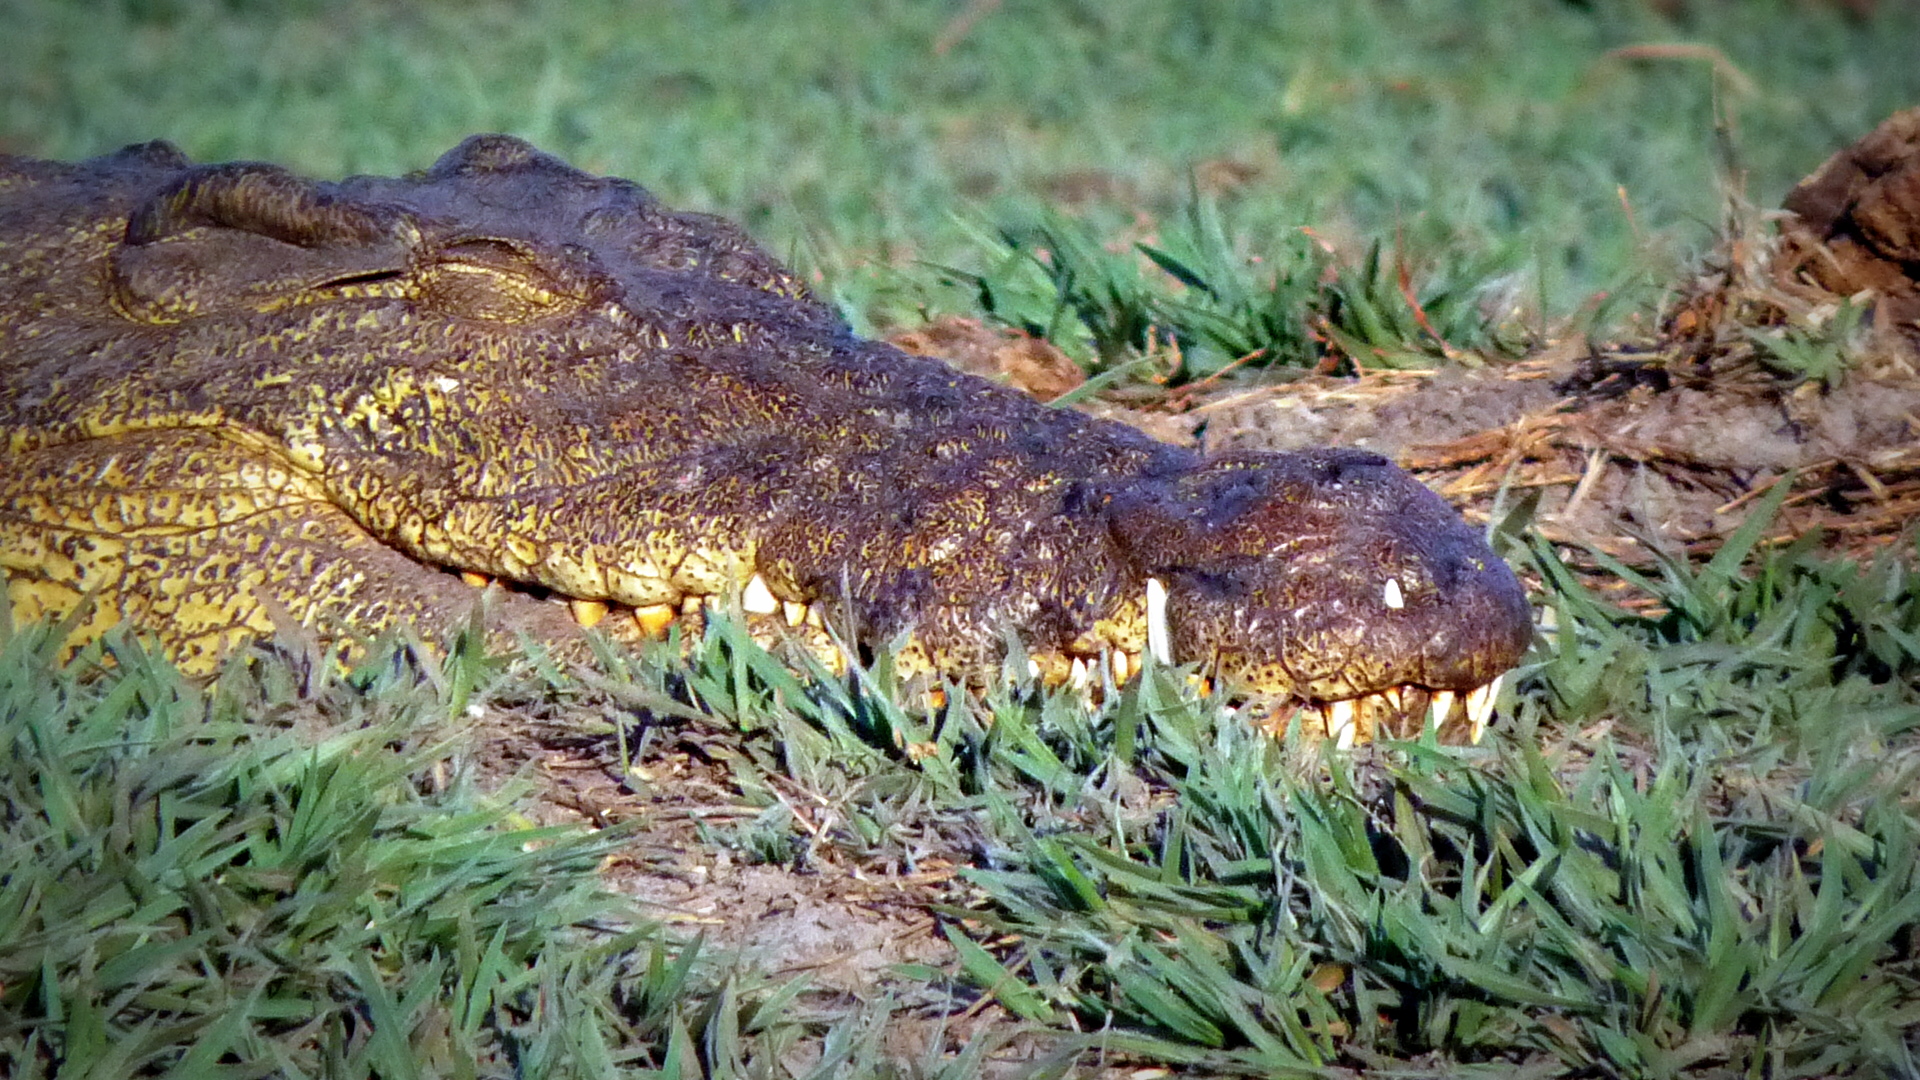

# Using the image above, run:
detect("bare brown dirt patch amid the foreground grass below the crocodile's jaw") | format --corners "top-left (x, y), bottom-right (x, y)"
top-left (474, 701), bottom-right (968, 994)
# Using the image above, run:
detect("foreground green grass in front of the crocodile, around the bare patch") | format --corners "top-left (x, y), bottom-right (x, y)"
top-left (0, 505), bottom-right (1920, 1080)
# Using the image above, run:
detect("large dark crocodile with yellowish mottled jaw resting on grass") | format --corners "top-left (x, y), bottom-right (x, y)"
top-left (0, 135), bottom-right (1530, 742)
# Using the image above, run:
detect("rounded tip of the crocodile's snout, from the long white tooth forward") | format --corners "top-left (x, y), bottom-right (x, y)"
top-left (1114, 450), bottom-right (1532, 738)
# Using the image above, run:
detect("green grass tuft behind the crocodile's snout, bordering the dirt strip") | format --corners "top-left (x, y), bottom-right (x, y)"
top-left (943, 202), bottom-right (1528, 376)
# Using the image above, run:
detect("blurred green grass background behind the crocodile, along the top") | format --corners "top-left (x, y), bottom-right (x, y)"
top-left (0, 0), bottom-right (1920, 327)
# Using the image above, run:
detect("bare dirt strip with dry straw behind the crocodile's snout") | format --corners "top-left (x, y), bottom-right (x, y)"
top-left (1202, 354), bottom-right (1920, 563)
